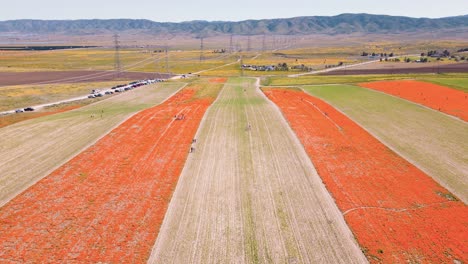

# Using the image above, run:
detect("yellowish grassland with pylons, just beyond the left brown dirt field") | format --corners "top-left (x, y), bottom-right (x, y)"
top-left (0, 48), bottom-right (237, 74)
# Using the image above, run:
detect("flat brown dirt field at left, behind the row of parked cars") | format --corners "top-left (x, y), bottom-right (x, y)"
top-left (0, 71), bottom-right (171, 86)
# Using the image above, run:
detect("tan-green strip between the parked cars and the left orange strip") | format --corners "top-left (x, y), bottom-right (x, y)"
top-left (0, 83), bottom-right (182, 205)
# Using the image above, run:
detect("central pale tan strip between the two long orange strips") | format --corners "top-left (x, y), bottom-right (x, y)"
top-left (149, 78), bottom-right (366, 263)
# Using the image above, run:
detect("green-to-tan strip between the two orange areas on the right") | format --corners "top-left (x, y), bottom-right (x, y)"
top-left (304, 85), bottom-right (468, 203)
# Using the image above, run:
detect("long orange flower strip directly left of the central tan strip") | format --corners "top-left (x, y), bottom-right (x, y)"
top-left (0, 85), bottom-right (219, 263)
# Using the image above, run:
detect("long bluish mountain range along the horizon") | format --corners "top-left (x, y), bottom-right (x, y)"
top-left (0, 14), bottom-right (468, 36)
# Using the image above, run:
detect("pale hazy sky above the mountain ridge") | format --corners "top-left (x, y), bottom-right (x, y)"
top-left (0, 0), bottom-right (468, 22)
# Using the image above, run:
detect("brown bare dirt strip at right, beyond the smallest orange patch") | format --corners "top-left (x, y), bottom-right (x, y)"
top-left (321, 63), bottom-right (468, 75)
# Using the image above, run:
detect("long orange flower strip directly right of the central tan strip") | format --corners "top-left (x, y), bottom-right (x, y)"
top-left (265, 89), bottom-right (468, 263)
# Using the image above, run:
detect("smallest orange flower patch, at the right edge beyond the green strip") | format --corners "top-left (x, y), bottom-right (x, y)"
top-left (360, 81), bottom-right (468, 121)
